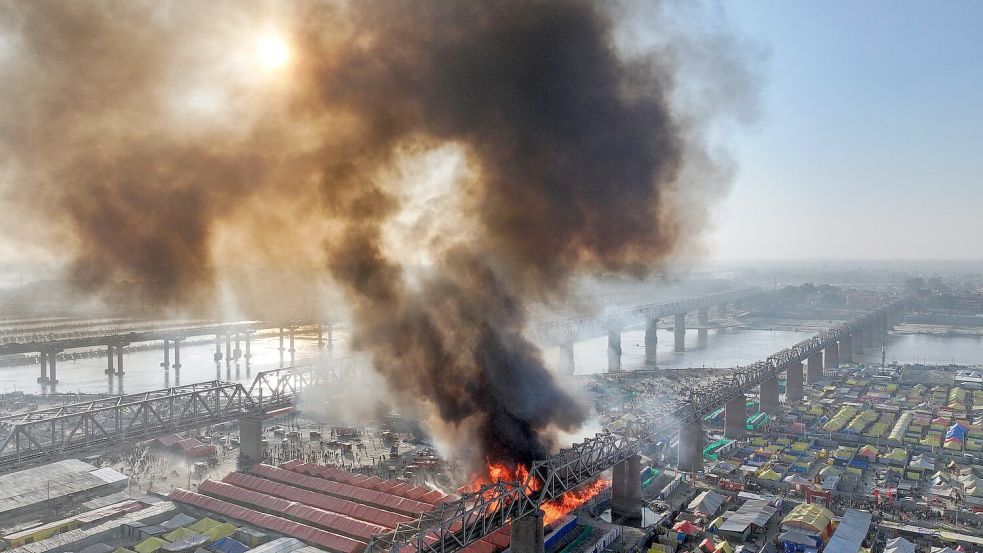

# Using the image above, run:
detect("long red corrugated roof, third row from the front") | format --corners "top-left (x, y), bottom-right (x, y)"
top-left (222, 472), bottom-right (413, 529)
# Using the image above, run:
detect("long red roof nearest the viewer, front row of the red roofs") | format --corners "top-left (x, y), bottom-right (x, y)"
top-left (167, 488), bottom-right (365, 553)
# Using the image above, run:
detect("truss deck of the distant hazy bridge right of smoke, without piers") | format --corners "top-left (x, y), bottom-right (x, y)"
top-left (529, 287), bottom-right (762, 343)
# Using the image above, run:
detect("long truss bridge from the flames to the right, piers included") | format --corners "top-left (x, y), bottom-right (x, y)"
top-left (366, 300), bottom-right (904, 553)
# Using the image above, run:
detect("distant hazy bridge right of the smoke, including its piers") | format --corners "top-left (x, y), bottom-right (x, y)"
top-left (529, 287), bottom-right (762, 374)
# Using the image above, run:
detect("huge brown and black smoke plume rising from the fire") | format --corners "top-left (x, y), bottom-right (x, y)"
top-left (0, 0), bottom-right (760, 468)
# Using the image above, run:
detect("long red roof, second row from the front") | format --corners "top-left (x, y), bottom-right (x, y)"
top-left (198, 480), bottom-right (387, 543)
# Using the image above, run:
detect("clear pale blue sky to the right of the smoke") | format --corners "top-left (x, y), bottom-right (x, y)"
top-left (711, 0), bottom-right (983, 259)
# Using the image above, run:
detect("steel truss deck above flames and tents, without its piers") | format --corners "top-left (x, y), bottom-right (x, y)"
top-left (366, 300), bottom-right (904, 553)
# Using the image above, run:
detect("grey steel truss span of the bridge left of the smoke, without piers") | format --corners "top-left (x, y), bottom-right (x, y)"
top-left (0, 356), bottom-right (366, 471)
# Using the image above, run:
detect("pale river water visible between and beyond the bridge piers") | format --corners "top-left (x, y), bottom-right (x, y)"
top-left (0, 329), bottom-right (983, 393)
